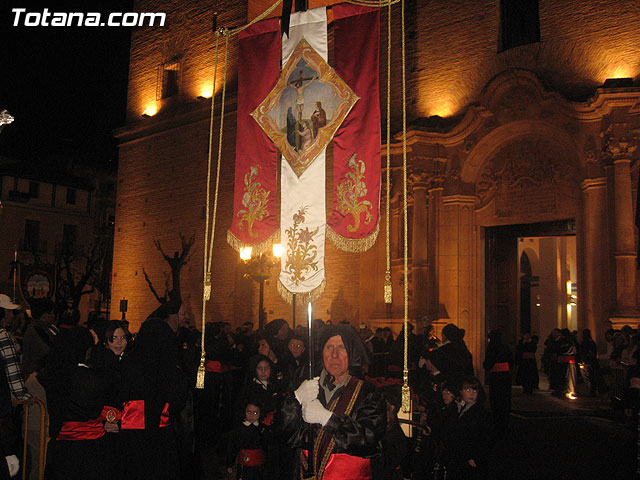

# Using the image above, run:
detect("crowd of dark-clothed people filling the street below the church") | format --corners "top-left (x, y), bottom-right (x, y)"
top-left (0, 295), bottom-right (640, 480)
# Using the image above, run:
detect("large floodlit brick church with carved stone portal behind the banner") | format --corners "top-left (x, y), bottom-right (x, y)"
top-left (113, 0), bottom-right (640, 370)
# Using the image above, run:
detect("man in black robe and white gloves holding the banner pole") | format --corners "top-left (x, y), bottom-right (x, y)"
top-left (276, 325), bottom-right (387, 480)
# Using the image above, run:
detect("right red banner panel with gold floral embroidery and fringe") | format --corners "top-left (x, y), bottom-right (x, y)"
top-left (327, 4), bottom-right (380, 252)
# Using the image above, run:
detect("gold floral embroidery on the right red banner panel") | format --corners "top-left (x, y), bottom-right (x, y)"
top-left (337, 154), bottom-right (373, 232)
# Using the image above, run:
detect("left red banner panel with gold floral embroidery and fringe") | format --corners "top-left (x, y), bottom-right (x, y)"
top-left (227, 18), bottom-right (280, 254)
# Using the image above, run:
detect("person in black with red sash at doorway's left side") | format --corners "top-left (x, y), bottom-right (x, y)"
top-left (482, 330), bottom-right (513, 433)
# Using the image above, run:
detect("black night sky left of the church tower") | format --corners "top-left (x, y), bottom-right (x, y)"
top-left (0, 0), bottom-right (133, 170)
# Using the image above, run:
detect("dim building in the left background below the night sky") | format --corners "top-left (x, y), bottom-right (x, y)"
top-left (0, 158), bottom-right (116, 321)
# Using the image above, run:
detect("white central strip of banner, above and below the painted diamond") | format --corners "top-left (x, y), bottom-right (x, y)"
top-left (279, 7), bottom-right (328, 302)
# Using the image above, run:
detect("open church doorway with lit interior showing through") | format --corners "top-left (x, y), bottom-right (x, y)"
top-left (485, 219), bottom-right (578, 348)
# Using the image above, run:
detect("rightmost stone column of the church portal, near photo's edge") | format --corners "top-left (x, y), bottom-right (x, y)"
top-left (604, 124), bottom-right (640, 317)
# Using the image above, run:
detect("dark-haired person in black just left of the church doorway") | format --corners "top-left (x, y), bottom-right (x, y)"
top-left (427, 323), bottom-right (473, 381)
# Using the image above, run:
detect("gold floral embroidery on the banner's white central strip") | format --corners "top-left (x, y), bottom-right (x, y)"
top-left (284, 207), bottom-right (320, 285)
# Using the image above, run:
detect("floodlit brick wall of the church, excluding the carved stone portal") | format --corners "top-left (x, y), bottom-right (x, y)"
top-left (112, 0), bottom-right (640, 330)
